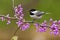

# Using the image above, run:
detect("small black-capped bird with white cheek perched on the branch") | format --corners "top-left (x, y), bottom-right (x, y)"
top-left (30, 9), bottom-right (47, 19)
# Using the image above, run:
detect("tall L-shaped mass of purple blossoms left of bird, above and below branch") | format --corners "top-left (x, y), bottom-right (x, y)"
top-left (14, 4), bottom-right (30, 31)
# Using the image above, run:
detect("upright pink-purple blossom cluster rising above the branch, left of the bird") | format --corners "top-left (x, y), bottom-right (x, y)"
top-left (14, 4), bottom-right (24, 20)
